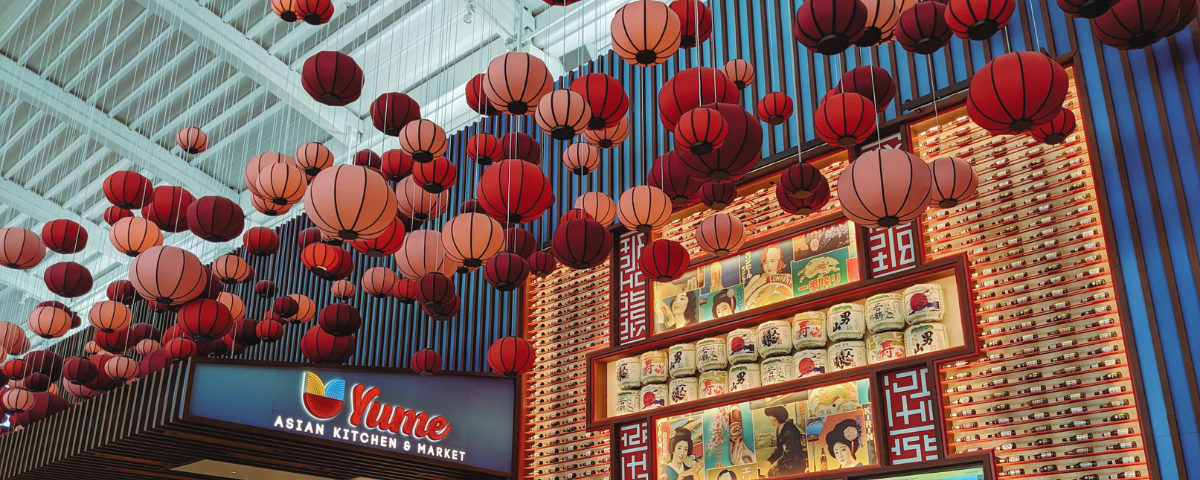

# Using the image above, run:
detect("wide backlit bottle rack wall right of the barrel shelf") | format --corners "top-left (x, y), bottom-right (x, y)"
top-left (912, 69), bottom-right (1150, 480)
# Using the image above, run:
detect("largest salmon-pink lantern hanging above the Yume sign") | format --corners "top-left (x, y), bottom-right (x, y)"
top-left (304, 164), bottom-right (396, 240)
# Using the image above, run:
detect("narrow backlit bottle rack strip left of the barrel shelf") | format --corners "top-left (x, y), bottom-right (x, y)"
top-left (522, 262), bottom-right (611, 480)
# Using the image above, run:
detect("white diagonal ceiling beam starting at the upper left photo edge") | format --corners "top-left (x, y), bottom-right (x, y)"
top-left (0, 56), bottom-right (235, 197)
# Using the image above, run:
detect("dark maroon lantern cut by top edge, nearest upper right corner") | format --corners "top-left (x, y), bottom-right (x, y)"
top-left (1092, 0), bottom-right (1192, 50)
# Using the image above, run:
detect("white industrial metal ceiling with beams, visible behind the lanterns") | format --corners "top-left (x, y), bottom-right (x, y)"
top-left (0, 0), bottom-right (623, 348)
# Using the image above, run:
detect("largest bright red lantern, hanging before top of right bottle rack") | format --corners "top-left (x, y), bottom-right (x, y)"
top-left (967, 52), bottom-right (1067, 133)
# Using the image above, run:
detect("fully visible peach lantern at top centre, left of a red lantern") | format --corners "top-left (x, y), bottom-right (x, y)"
top-left (610, 0), bottom-right (680, 67)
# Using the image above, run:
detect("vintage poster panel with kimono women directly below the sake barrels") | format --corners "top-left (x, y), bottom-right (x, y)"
top-left (654, 378), bottom-right (878, 480)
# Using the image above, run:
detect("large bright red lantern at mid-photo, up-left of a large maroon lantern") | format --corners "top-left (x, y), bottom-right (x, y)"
top-left (475, 160), bottom-right (554, 223)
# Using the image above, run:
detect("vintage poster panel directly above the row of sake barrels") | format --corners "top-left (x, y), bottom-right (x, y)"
top-left (654, 221), bottom-right (859, 334)
